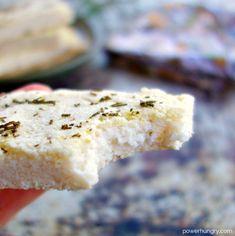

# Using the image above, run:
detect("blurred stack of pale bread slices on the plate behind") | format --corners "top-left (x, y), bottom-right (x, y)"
top-left (0, 0), bottom-right (88, 79)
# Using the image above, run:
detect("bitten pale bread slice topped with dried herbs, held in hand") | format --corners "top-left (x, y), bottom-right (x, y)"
top-left (0, 89), bottom-right (194, 190)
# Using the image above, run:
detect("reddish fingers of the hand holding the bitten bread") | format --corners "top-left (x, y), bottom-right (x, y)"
top-left (0, 84), bottom-right (50, 227)
